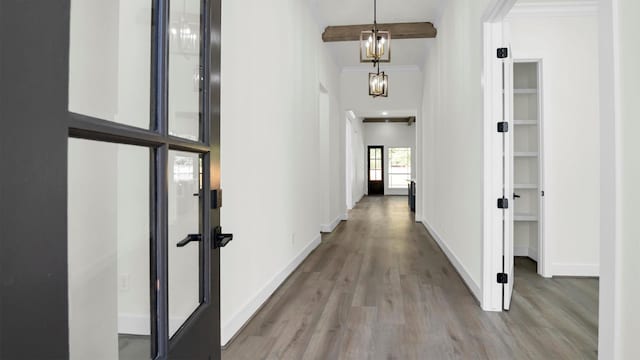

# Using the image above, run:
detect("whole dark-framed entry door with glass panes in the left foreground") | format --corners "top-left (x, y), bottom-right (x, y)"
top-left (0, 0), bottom-right (224, 359)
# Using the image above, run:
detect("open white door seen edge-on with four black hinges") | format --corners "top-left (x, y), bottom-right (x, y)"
top-left (498, 43), bottom-right (515, 310)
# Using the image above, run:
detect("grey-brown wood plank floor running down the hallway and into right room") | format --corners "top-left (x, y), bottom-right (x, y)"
top-left (223, 197), bottom-right (598, 360)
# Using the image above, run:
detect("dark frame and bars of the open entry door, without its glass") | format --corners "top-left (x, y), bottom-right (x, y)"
top-left (0, 0), bottom-right (221, 359)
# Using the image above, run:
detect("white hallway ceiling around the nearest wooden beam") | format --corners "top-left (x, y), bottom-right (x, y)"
top-left (311, 0), bottom-right (445, 69)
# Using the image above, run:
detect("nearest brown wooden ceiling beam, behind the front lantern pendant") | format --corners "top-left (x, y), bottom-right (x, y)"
top-left (322, 22), bottom-right (438, 42)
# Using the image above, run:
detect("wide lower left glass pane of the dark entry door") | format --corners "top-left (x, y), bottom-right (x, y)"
top-left (67, 139), bottom-right (151, 360)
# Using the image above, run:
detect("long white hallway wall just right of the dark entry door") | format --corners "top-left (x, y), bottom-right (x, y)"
top-left (221, 0), bottom-right (346, 344)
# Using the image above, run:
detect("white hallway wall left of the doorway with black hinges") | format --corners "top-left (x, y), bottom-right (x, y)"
top-left (418, 0), bottom-right (490, 298)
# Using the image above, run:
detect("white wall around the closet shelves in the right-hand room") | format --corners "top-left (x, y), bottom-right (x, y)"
top-left (507, 13), bottom-right (600, 276)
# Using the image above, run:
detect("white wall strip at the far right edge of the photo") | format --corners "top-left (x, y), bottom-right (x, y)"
top-left (603, 0), bottom-right (640, 359)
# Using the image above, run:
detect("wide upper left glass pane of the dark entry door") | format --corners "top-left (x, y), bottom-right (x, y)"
top-left (69, 0), bottom-right (152, 129)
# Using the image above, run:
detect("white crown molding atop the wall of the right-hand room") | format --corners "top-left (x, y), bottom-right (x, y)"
top-left (507, 0), bottom-right (598, 18)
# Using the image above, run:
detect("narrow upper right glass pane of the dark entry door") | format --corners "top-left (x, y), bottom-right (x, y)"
top-left (169, 0), bottom-right (202, 141)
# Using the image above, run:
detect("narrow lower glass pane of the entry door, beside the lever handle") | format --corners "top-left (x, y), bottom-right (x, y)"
top-left (169, 151), bottom-right (202, 336)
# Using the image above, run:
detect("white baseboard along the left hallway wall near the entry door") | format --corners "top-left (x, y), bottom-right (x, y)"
top-left (221, 234), bottom-right (321, 346)
